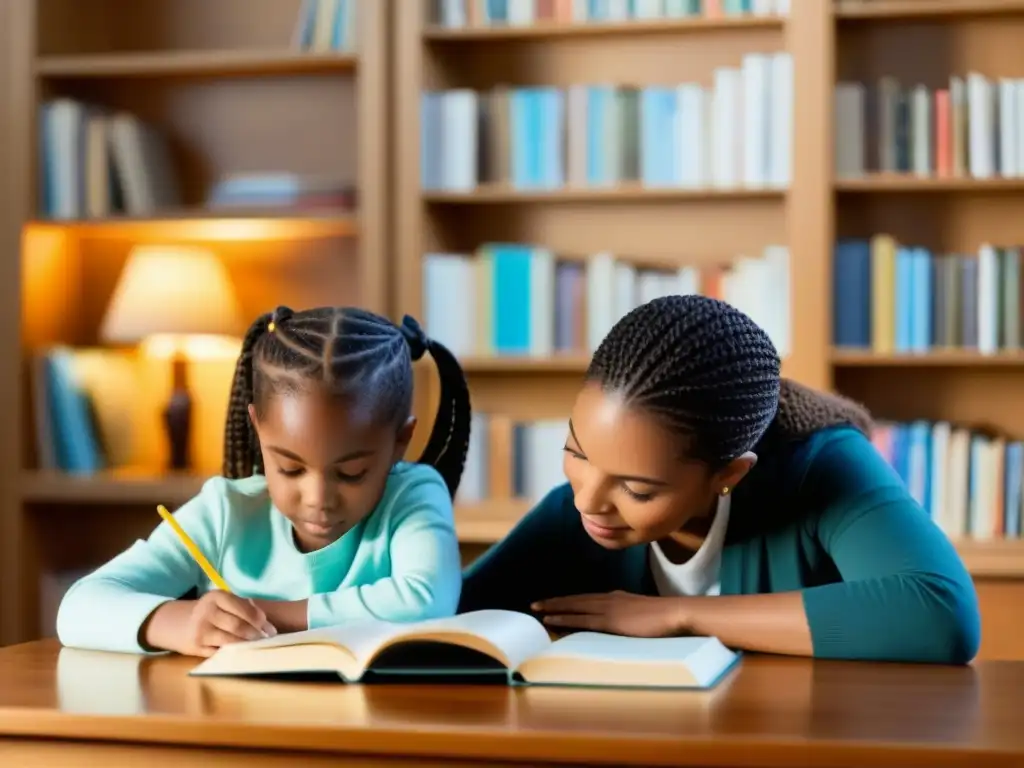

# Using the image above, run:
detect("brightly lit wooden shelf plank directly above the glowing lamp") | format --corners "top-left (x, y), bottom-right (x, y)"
top-left (29, 209), bottom-right (358, 242)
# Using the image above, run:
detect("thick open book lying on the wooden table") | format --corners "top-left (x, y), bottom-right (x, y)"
top-left (191, 610), bottom-right (739, 688)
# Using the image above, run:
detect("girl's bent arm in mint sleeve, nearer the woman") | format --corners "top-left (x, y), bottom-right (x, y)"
top-left (255, 466), bottom-right (462, 632)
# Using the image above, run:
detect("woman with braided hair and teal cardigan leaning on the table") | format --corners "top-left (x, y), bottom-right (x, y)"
top-left (460, 296), bottom-right (980, 664)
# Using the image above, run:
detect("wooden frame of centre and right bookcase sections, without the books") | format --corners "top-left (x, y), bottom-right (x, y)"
top-left (394, 0), bottom-right (1024, 657)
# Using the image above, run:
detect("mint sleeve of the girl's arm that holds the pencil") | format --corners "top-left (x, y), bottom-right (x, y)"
top-left (56, 477), bottom-right (225, 653)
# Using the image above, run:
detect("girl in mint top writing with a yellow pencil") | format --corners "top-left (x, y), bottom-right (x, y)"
top-left (57, 307), bottom-right (470, 656)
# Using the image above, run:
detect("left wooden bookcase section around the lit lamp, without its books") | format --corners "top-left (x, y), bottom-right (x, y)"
top-left (0, 0), bottom-right (390, 643)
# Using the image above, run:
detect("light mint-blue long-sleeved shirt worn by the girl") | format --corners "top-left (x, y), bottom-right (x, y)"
top-left (56, 462), bottom-right (462, 653)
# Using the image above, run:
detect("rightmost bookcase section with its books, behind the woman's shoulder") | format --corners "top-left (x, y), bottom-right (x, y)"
top-left (828, 0), bottom-right (1024, 658)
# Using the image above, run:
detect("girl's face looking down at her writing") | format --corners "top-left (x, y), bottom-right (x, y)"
top-left (249, 386), bottom-right (415, 552)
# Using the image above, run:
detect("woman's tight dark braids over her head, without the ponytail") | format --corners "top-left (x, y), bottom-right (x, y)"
top-left (587, 295), bottom-right (780, 465)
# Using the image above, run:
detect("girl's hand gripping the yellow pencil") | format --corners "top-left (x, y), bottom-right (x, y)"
top-left (144, 591), bottom-right (278, 656)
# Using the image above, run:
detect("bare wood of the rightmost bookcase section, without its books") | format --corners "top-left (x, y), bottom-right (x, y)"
top-left (828, 0), bottom-right (1024, 658)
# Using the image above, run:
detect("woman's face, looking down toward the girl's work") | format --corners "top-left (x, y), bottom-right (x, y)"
top-left (563, 383), bottom-right (750, 549)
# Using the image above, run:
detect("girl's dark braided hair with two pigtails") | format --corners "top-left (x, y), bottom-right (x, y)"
top-left (223, 306), bottom-right (472, 497)
